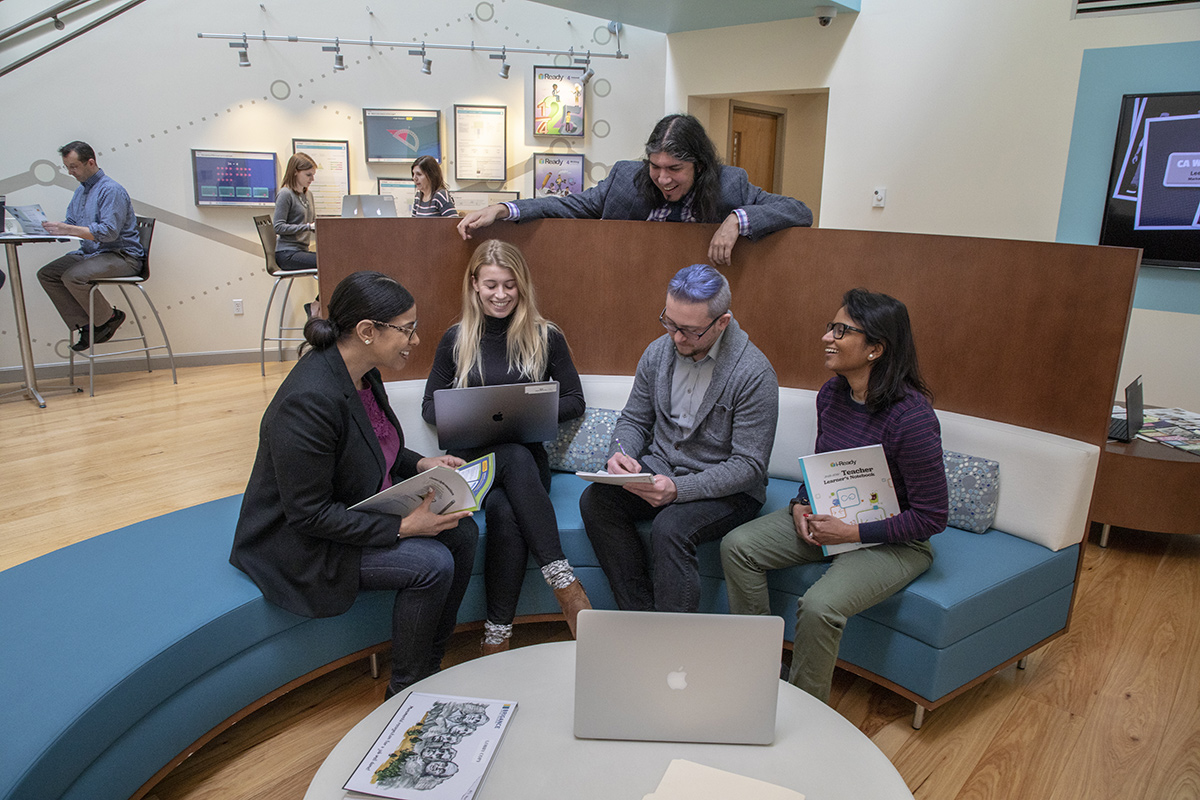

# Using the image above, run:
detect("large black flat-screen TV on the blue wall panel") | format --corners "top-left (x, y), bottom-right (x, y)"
top-left (1100, 91), bottom-right (1200, 270)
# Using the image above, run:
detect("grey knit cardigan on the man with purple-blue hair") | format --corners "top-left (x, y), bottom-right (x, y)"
top-left (608, 320), bottom-right (779, 503)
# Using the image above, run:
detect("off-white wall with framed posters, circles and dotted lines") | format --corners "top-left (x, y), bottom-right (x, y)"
top-left (0, 0), bottom-right (666, 371)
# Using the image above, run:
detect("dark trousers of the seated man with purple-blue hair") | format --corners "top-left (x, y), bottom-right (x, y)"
top-left (580, 483), bottom-right (762, 612)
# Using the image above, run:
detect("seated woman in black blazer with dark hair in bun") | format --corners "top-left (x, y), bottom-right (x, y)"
top-left (229, 272), bottom-right (479, 697)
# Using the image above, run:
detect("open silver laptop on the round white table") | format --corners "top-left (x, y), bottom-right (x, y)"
top-left (575, 610), bottom-right (784, 745)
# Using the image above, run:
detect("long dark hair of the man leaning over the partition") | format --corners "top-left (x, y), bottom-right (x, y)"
top-left (634, 114), bottom-right (722, 222)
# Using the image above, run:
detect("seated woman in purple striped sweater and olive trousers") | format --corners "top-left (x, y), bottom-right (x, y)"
top-left (721, 289), bottom-right (949, 702)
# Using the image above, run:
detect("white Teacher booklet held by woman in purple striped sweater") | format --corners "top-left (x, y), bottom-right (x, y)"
top-left (800, 445), bottom-right (900, 555)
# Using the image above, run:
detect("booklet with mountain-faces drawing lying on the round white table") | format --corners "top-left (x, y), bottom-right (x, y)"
top-left (342, 692), bottom-right (517, 800)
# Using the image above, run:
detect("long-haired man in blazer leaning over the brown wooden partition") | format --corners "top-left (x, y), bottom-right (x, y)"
top-left (458, 114), bottom-right (812, 264)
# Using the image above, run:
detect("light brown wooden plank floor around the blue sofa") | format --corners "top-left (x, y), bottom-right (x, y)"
top-left (7, 365), bottom-right (1200, 800)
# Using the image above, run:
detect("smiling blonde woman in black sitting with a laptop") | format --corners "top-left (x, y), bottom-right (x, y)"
top-left (421, 239), bottom-right (592, 655)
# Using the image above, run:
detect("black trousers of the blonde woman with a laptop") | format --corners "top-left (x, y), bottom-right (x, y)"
top-left (455, 444), bottom-right (566, 625)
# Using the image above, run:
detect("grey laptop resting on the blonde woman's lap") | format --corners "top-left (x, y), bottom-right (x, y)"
top-left (433, 380), bottom-right (558, 450)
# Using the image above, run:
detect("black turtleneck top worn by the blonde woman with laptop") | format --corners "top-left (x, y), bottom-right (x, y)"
top-left (421, 314), bottom-right (583, 425)
